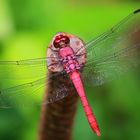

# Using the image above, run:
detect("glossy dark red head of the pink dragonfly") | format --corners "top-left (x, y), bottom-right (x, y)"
top-left (53, 34), bottom-right (70, 48)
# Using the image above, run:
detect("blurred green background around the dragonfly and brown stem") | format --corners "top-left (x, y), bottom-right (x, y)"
top-left (0, 0), bottom-right (140, 140)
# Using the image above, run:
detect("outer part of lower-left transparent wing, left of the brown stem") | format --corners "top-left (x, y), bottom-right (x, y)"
top-left (0, 78), bottom-right (45, 108)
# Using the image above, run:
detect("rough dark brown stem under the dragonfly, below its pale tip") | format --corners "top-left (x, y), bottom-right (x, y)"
top-left (39, 73), bottom-right (78, 140)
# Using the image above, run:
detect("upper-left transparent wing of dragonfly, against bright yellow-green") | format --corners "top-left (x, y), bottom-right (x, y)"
top-left (0, 57), bottom-right (59, 80)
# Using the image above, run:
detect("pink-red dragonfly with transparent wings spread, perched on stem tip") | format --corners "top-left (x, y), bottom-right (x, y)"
top-left (0, 9), bottom-right (140, 136)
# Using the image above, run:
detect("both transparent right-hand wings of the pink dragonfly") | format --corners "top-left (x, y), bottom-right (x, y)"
top-left (77, 9), bottom-right (140, 86)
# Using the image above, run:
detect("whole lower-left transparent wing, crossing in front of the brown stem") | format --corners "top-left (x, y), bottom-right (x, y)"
top-left (0, 73), bottom-right (69, 108)
